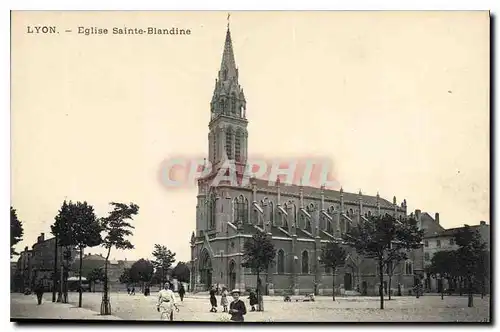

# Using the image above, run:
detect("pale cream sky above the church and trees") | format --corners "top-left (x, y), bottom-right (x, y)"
top-left (11, 12), bottom-right (490, 261)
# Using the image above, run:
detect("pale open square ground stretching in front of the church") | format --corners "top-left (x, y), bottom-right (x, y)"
top-left (11, 293), bottom-right (489, 322)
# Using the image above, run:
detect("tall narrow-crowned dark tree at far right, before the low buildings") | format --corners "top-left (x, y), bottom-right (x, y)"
top-left (455, 226), bottom-right (486, 307)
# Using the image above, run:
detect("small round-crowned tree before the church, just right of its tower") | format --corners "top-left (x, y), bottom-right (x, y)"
top-left (242, 231), bottom-right (276, 311)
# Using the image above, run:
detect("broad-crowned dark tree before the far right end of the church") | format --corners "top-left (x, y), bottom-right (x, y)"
top-left (343, 214), bottom-right (423, 309)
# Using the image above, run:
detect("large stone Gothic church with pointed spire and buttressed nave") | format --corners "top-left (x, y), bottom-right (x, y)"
top-left (190, 25), bottom-right (423, 295)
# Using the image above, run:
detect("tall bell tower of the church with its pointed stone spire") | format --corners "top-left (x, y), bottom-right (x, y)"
top-left (208, 23), bottom-right (248, 169)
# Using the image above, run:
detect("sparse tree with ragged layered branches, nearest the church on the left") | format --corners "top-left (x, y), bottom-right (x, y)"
top-left (101, 202), bottom-right (139, 315)
